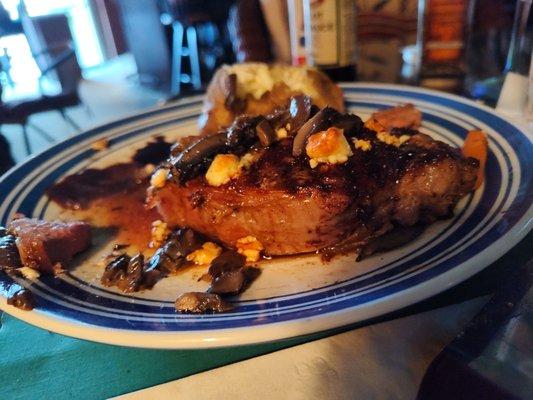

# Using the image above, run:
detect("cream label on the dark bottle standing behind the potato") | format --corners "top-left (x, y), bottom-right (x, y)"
top-left (304, 0), bottom-right (356, 68)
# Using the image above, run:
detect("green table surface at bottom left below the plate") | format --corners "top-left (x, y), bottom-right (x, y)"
top-left (0, 313), bottom-right (309, 400)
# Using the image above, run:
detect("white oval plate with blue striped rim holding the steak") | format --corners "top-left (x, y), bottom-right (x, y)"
top-left (0, 84), bottom-right (533, 348)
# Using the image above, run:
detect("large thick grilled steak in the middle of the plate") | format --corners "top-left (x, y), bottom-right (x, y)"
top-left (149, 101), bottom-right (478, 255)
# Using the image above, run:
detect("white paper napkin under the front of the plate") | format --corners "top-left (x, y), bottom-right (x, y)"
top-left (116, 298), bottom-right (487, 400)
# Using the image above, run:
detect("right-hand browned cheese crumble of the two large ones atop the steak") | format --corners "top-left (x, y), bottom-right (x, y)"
top-left (305, 127), bottom-right (353, 168)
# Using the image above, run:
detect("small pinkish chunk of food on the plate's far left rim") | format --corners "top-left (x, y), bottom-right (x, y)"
top-left (8, 218), bottom-right (91, 272)
